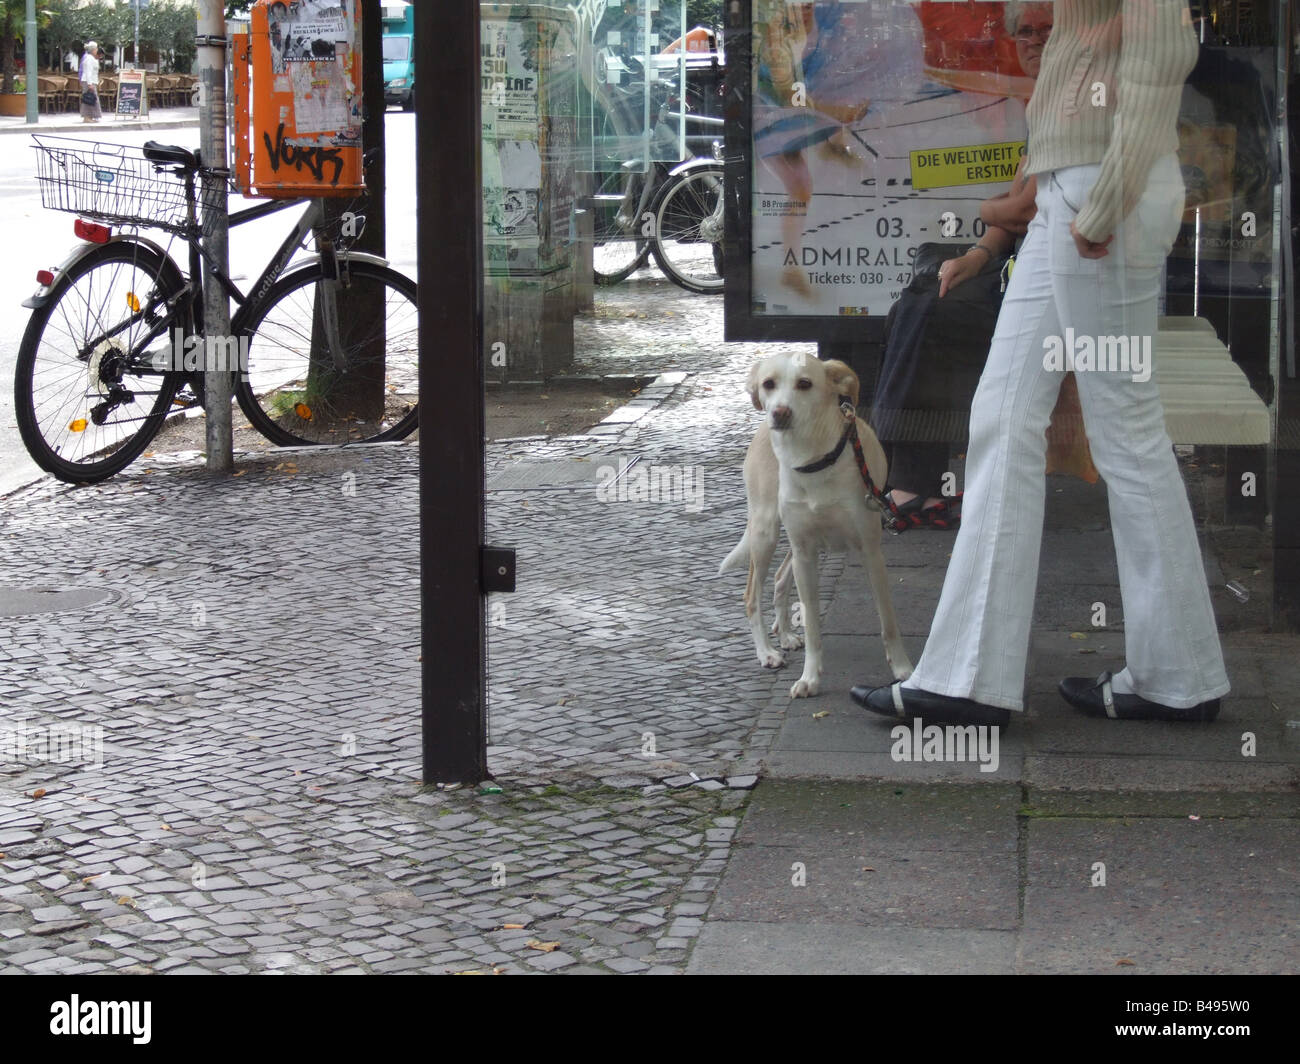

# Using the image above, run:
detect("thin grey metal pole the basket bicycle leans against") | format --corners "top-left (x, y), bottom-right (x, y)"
top-left (195, 0), bottom-right (234, 473)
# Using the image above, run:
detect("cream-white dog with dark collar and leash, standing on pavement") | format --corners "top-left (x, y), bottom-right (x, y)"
top-left (718, 355), bottom-right (911, 698)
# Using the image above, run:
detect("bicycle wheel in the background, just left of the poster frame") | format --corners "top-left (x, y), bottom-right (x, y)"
top-left (650, 166), bottom-right (723, 293)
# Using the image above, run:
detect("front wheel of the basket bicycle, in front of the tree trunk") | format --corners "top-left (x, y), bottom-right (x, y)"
top-left (235, 263), bottom-right (420, 446)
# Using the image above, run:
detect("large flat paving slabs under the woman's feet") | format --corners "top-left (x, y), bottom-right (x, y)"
top-left (688, 479), bottom-right (1300, 974)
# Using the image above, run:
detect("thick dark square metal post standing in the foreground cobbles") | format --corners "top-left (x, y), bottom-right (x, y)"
top-left (415, 0), bottom-right (488, 783)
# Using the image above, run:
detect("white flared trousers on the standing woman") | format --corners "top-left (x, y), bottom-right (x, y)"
top-left (904, 155), bottom-right (1229, 710)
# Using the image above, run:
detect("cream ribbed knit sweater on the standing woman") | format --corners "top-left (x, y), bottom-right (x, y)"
top-left (1028, 0), bottom-right (1197, 241)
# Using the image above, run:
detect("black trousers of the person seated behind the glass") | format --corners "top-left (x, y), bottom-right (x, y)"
top-left (871, 246), bottom-right (1005, 498)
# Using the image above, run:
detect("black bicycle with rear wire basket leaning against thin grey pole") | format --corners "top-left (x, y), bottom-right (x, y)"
top-left (14, 137), bottom-right (419, 483)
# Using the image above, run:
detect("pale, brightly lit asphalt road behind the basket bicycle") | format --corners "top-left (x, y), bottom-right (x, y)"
top-left (0, 111), bottom-right (416, 494)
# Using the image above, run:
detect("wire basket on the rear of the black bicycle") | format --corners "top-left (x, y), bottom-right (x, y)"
top-left (33, 135), bottom-right (228, 235)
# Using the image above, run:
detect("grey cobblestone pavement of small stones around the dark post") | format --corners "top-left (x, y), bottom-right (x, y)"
top-left (0, 282), bottom-right (831, 973)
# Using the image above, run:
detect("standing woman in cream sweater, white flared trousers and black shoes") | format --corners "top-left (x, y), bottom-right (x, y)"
top-left (853, 0), bottom-right (1229, 725)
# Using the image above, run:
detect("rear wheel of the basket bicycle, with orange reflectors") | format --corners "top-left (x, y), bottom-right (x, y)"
top-left (14, 241), bottom-right (185, 484)
